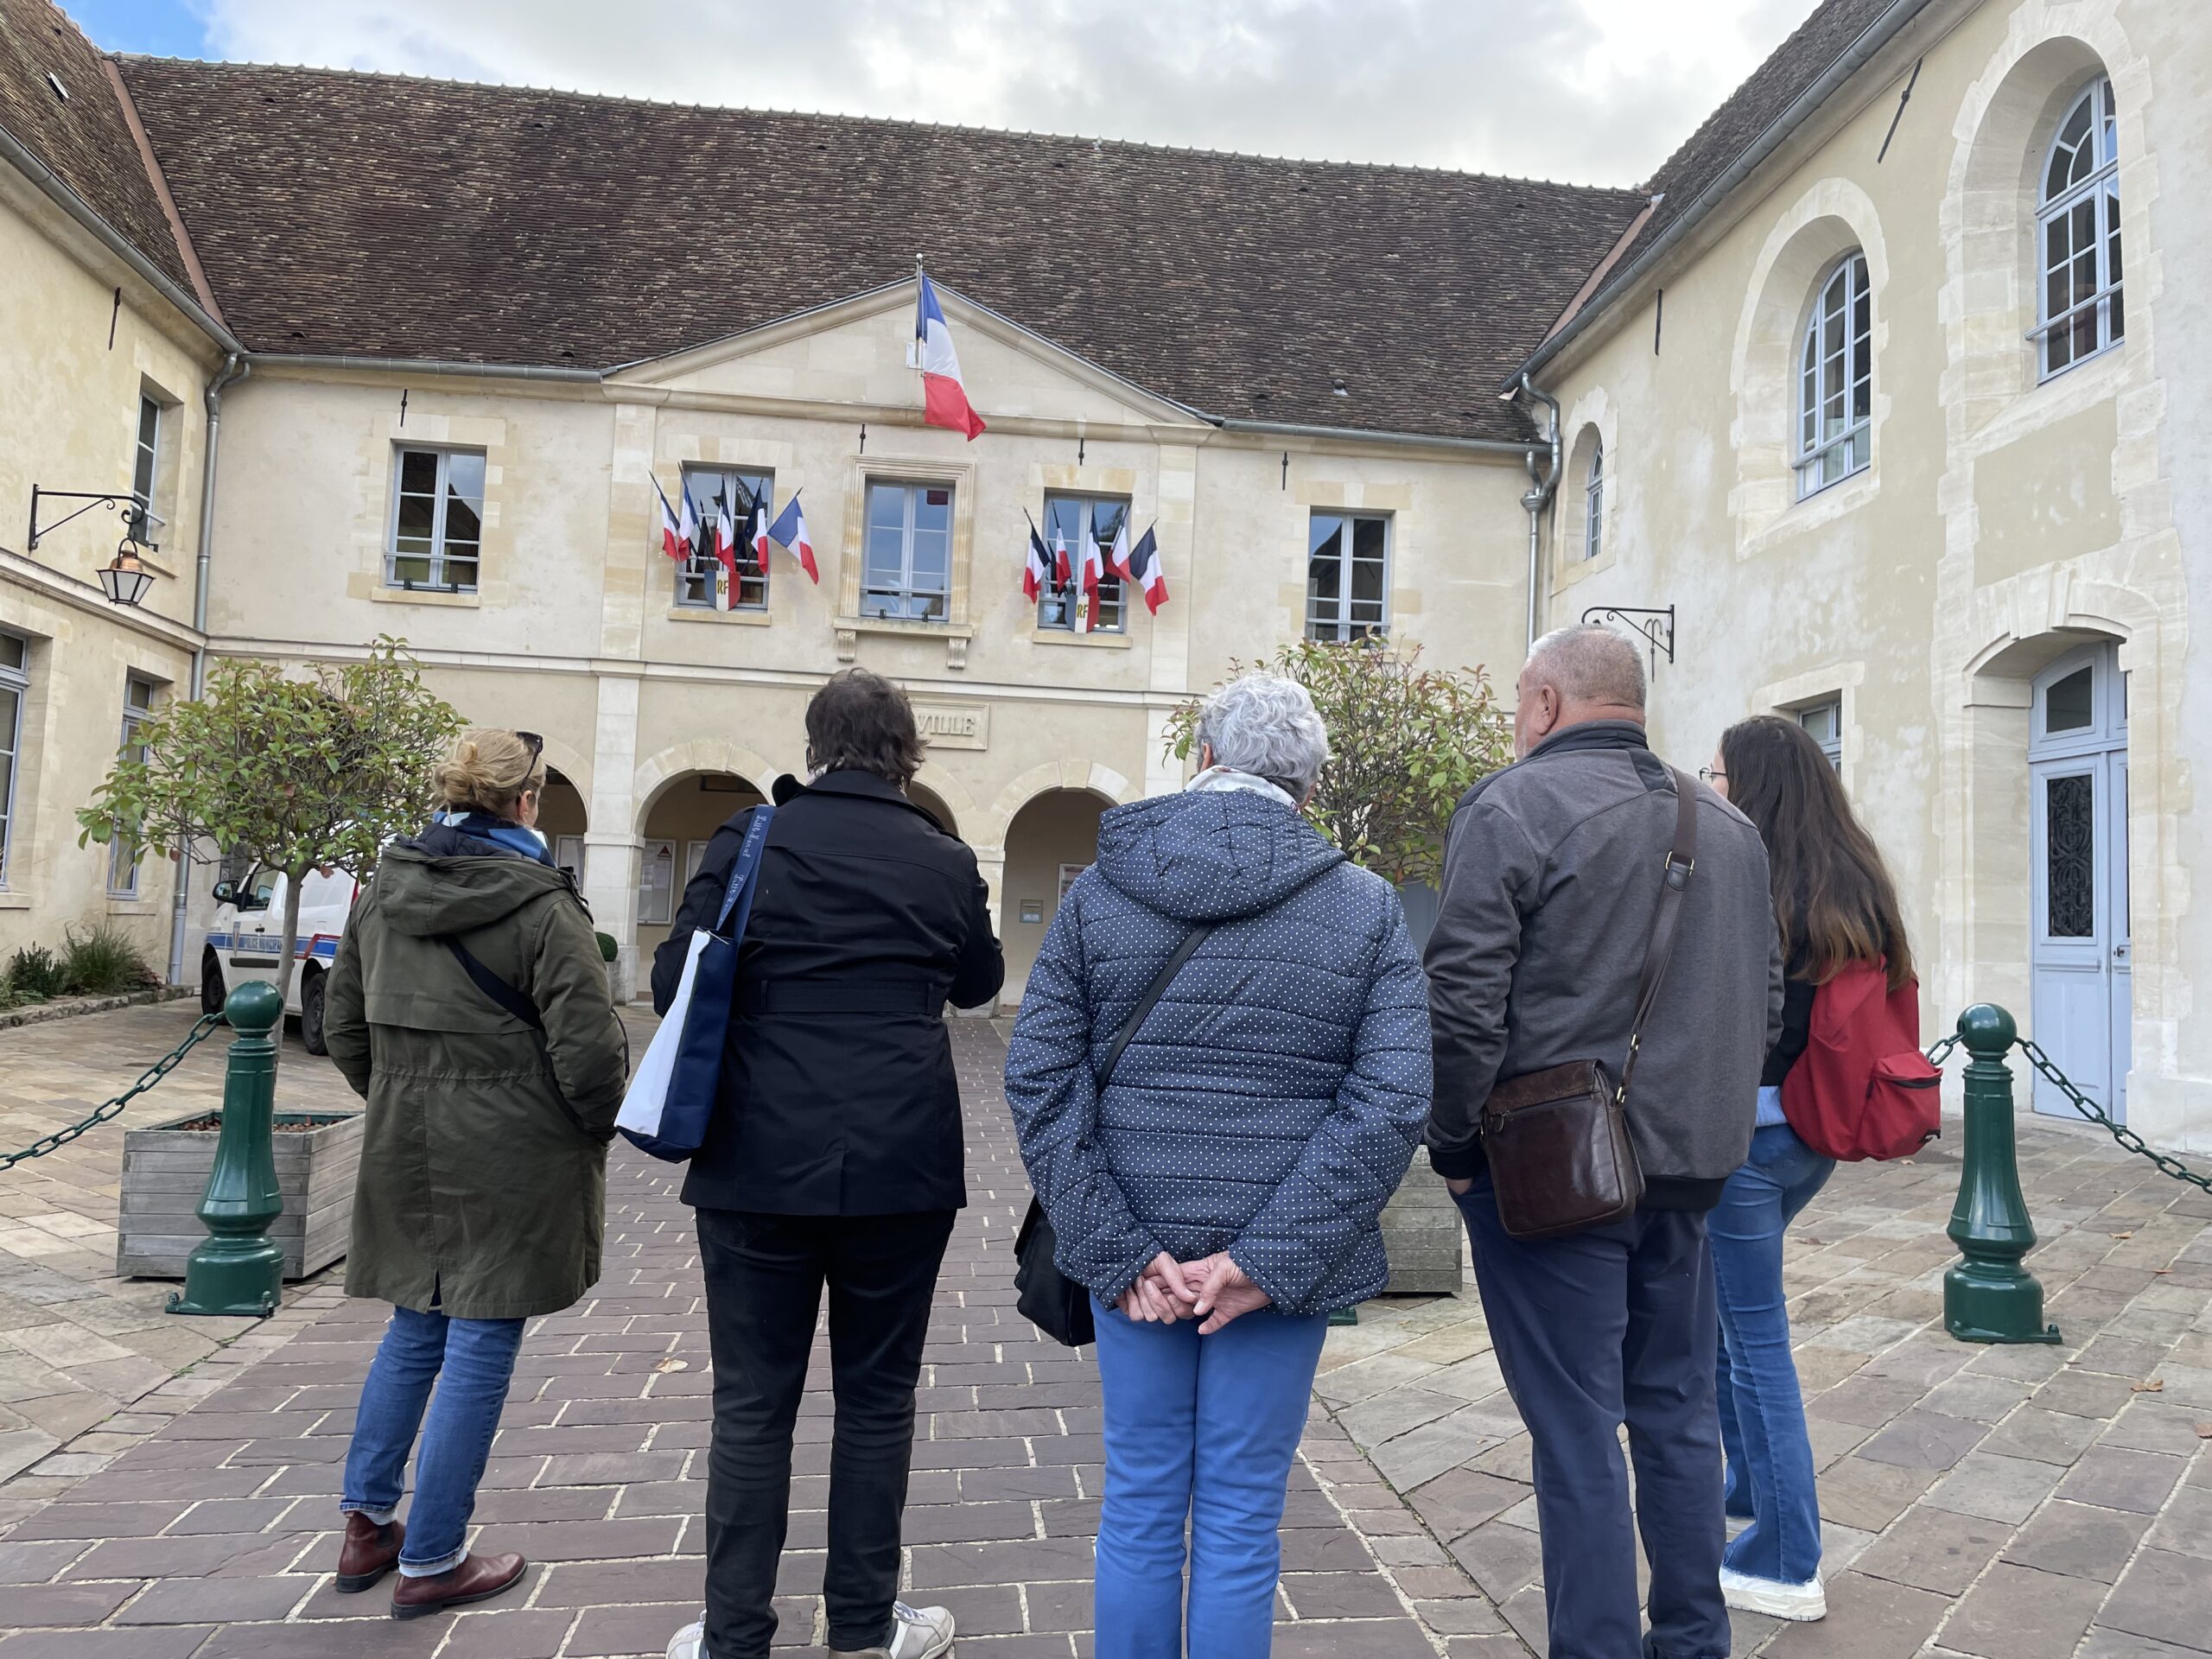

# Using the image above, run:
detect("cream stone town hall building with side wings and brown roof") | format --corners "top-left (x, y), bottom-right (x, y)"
top-left (13, 0), bottom-right (2212, 1148)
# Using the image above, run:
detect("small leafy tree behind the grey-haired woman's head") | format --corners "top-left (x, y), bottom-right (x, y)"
top-left (1168, 639), bottom-right (1513, 887)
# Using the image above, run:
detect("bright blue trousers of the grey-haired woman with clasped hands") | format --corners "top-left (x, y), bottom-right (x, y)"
top-left (1093, 1303), bottom-right (1330, 1659)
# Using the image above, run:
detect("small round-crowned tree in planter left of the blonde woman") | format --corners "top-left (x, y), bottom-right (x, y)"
top-left (78, 637), bottom-right (460, 1008)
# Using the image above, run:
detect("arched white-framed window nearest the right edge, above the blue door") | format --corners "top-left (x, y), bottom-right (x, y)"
top-left (2035, 79), bottom-right (2128, 378)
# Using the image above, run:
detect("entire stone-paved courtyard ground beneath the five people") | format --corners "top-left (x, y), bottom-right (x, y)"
top-left (0, 1008), bottom-right (2212, 1659)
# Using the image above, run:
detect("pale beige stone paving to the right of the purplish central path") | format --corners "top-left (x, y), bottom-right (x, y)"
top-left (1316, 1119), bottom-right (2212, 1659)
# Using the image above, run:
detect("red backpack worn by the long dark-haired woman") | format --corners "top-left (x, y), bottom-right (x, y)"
top-left (1783, 963), bottom-right (1942, 1164)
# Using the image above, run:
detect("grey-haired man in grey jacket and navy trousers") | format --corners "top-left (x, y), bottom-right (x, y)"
top-left (1427, 628), bottom-right (1783, 1659)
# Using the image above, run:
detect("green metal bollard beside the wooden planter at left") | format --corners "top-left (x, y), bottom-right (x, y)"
top-left (168, 980), bottom-right (283, 1319)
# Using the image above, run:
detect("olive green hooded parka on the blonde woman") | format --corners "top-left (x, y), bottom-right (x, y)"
top-left (323, 825), bottom-right (626, 1319)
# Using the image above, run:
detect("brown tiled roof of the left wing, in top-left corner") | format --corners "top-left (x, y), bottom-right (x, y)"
top-left (0, 0), bottom-right (193, 292)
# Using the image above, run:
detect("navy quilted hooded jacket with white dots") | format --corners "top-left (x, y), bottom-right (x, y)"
top-left (1007, 790), bottom-right (1429, 1314)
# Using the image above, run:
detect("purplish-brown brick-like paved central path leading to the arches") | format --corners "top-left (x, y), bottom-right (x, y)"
top-left (0, 1022), bottom-right (1435, 1659)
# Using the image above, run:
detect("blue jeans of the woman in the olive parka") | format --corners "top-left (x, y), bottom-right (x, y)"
top-left (339, 1307), bottom-right (522, 1577)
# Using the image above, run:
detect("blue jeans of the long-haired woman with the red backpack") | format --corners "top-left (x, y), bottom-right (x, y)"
top-left (1707, 1123), bottom-right (1836, 1584)
